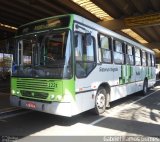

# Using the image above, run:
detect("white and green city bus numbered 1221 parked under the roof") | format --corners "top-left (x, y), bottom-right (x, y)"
top-left (10, 14), bottom-right (156, 117)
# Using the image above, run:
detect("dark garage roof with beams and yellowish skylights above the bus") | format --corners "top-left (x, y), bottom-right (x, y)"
top-left (0, 0), bottom-right (160, 57)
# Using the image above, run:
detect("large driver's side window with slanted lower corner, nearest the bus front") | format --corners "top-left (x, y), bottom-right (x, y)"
top-left (74, 33), bottom-right (95, 78)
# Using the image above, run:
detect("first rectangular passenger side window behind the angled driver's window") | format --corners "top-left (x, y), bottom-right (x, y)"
top-left (99, 34), bottom-right (112, 63)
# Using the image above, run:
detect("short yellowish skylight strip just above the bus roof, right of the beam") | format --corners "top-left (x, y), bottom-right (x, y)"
top-left (121, 29), bottom-right (148, 43)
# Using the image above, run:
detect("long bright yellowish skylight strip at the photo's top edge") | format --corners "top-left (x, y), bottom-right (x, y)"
top-left (72, 0), bottom-right (113, 21)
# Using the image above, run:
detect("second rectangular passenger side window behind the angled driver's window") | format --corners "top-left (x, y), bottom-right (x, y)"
top-left (114, 40), bottom-right (124, 64)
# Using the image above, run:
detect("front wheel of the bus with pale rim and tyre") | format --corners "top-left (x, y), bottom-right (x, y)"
top-left (94, 87), bottom-right (108, 115)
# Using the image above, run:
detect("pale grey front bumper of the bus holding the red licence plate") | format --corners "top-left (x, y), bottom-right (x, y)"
top-left (10, 96), bottom-right (72, 117)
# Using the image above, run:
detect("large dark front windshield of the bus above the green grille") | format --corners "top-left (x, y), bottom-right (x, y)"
top-left (12, 31), bottom-right (72, 78)
